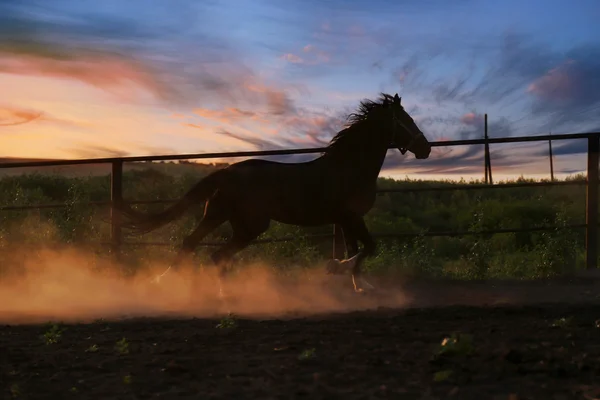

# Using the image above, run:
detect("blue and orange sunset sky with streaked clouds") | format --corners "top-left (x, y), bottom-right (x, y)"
top-left (0, 0), bottom-right (600, 178)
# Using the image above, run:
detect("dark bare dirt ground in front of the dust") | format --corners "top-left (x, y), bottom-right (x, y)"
top-left (0, 279), bottom-right (600, 400)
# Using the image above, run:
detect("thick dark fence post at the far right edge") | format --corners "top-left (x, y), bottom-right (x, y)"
top-left (585, 134), bottom-right (600, 270)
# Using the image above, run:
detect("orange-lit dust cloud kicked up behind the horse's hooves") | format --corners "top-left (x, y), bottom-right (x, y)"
top-left (0, 244), bottom-right (406, 324)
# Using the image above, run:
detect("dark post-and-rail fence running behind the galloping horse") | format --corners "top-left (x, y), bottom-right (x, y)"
top-left (0, 133), bottom-right (600, 269)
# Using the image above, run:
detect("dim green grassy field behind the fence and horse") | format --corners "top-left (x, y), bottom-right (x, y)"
top-left (0, 163), bottom-right (585, 279)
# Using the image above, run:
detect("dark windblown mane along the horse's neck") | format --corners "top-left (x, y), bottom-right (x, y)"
top-left (326, 93), bottom-right (394, 153)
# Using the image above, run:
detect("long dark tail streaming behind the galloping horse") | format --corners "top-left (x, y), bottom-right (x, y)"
top-left (119, 171), bottom-right (222, 234)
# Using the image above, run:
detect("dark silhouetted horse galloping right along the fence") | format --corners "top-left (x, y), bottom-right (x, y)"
top-left (115, 93), bottom-right (431, 292)
